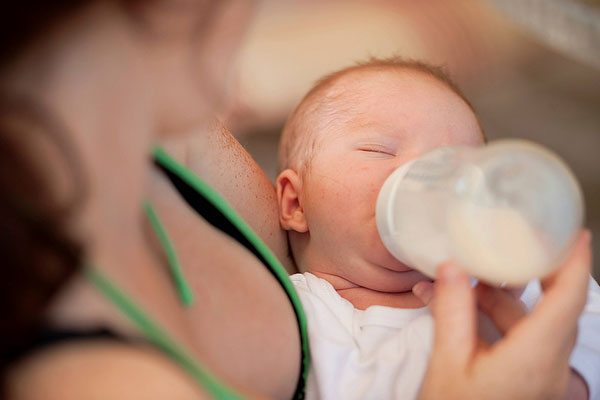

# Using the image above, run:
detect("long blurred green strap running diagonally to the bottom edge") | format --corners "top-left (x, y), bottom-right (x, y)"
top-left (84, 267), bottom-right (243, 400)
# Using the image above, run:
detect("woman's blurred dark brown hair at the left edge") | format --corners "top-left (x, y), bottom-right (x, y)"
top-left (0, 0), bottom-right (90, 388)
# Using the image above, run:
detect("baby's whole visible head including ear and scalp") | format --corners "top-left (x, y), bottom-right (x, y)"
top-left (277, 59), bottom-right (484, 292)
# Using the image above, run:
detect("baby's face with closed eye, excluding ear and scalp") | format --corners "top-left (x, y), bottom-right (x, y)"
top-left (302, 71), bottom-right (483, 291)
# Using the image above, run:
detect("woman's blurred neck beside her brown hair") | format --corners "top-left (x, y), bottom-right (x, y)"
top-left (2, 2), bottom-right (155, 274)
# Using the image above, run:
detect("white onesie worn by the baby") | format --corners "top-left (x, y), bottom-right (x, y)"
top-left (290, 272), bottom-right (600, 400)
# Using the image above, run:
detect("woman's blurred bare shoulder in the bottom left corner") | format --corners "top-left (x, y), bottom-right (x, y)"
top-left (7, 340), bottom-right (208, 400)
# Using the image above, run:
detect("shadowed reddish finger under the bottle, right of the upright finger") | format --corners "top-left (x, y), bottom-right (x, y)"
top-left (475, 283), bottom-right (527, 335)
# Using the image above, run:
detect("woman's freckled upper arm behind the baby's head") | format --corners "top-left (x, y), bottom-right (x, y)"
top-left (155, 120), bottom-right (297, 273)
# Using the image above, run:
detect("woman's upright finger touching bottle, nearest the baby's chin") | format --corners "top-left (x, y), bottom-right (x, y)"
top-left (431, 263), bottom-right (477, 367)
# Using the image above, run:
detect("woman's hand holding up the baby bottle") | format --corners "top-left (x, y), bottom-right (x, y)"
top-left (413, 232), bottom-right (591, 400)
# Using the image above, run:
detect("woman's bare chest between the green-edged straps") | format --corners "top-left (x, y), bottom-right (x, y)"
top-left (148, 179), bottom-right (301, 397)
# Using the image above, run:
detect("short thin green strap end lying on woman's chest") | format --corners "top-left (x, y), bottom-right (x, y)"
top-left (143, 200), bottom-right (194, 307)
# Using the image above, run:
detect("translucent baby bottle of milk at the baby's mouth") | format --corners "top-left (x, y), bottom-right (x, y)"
top-left (376, 140), bottom-right (583, 285)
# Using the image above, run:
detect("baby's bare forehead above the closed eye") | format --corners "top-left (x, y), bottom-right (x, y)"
top-left (307, 67), bottom-right (483, 140)
